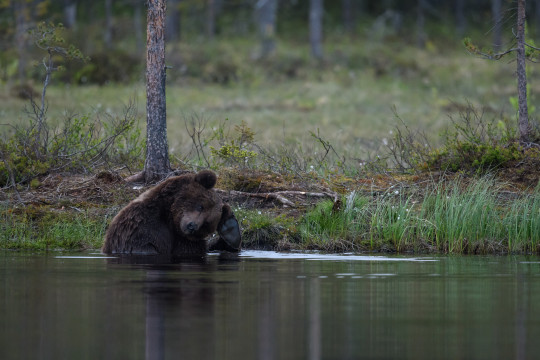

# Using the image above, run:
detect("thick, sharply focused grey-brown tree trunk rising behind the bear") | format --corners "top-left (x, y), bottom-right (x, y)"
top-left (144, 0), bottom-right (170, 183)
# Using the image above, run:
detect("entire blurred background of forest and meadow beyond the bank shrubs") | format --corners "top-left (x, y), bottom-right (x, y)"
top-left (4, 0), bottom-right (540, 167)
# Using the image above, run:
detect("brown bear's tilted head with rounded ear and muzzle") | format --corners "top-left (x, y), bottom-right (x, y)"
top-left (170, 170), bottom-right (224, 241)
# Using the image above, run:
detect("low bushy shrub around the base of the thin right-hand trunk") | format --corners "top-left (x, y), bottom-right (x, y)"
top-left (389, 105), bottom-right (540, 174)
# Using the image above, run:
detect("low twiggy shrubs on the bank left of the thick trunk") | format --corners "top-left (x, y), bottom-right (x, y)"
top-left (0, 104), bottom-right (144, 186)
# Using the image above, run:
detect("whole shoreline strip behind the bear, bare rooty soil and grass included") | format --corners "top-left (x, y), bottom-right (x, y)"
top-left (0, 168), bottom-right (540, 255)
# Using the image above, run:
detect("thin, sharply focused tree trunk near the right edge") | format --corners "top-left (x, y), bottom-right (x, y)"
top-left (517, 0), bottom-right (529, 142)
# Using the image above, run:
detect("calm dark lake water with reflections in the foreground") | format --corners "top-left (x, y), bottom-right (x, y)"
top-left (0, 251), bottom-right (540, 360)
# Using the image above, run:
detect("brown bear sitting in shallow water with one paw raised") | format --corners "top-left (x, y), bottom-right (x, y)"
top-left (101, 170), bottom-right (241, 256)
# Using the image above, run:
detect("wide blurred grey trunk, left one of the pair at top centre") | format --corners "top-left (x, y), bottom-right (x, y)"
top-left (255, 0), bottom-right (277, 58)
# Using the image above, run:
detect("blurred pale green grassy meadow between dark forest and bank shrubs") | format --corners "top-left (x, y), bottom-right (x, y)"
top-left (0, 36), bottom-right (524, 162)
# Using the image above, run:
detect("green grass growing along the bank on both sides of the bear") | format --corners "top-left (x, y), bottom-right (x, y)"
top-left (0, 170), bottom-right (540, 254)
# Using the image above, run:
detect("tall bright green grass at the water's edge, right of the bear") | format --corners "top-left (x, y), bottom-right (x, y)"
top-left (299, 178), bottom-right (540, 254)
